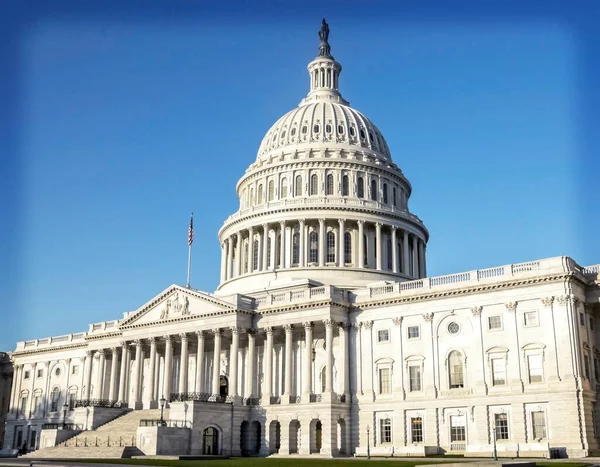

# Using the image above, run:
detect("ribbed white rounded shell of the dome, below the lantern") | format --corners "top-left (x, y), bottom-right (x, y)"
top-left (257, 102), bottom-right (391, 161)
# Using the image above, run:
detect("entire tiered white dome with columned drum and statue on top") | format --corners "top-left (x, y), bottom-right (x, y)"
top-left (218, 19), bottom-right (429, 294)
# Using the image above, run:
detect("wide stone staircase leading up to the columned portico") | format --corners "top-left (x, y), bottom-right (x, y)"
top-left (22, 409), bottom-right (169, 459)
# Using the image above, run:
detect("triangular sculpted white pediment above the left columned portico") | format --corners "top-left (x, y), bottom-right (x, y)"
top-left (119, 285), bottom-right (235, 328)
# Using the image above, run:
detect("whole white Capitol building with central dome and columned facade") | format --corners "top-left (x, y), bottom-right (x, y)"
top-left (4, 21), bottom-right (600, 457)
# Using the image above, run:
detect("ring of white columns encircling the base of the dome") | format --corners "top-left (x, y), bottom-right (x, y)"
top-left (221, 218), bottom-right (426, 282)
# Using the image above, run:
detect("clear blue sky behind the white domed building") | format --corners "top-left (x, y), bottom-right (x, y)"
top-left (0, 1), bottom-right (600, 350)
